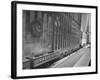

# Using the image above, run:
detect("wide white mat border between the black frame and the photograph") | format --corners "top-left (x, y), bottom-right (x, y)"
top-left (16, 4), bottom-right (96, 77)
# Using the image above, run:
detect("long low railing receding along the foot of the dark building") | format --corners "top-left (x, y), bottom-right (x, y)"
top-left (26, 47), bottom-right (81, 69)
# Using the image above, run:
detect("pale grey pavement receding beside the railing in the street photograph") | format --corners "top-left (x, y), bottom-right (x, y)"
top-left (50, 46), bottom-right (91, 68)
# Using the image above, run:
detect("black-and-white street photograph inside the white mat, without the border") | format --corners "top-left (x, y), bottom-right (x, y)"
top-left (22, 10), bottom-right (91, 69)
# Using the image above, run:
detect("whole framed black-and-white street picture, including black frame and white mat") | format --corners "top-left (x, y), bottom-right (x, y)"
top-left (12, 2), bottom-right (97, 78)
